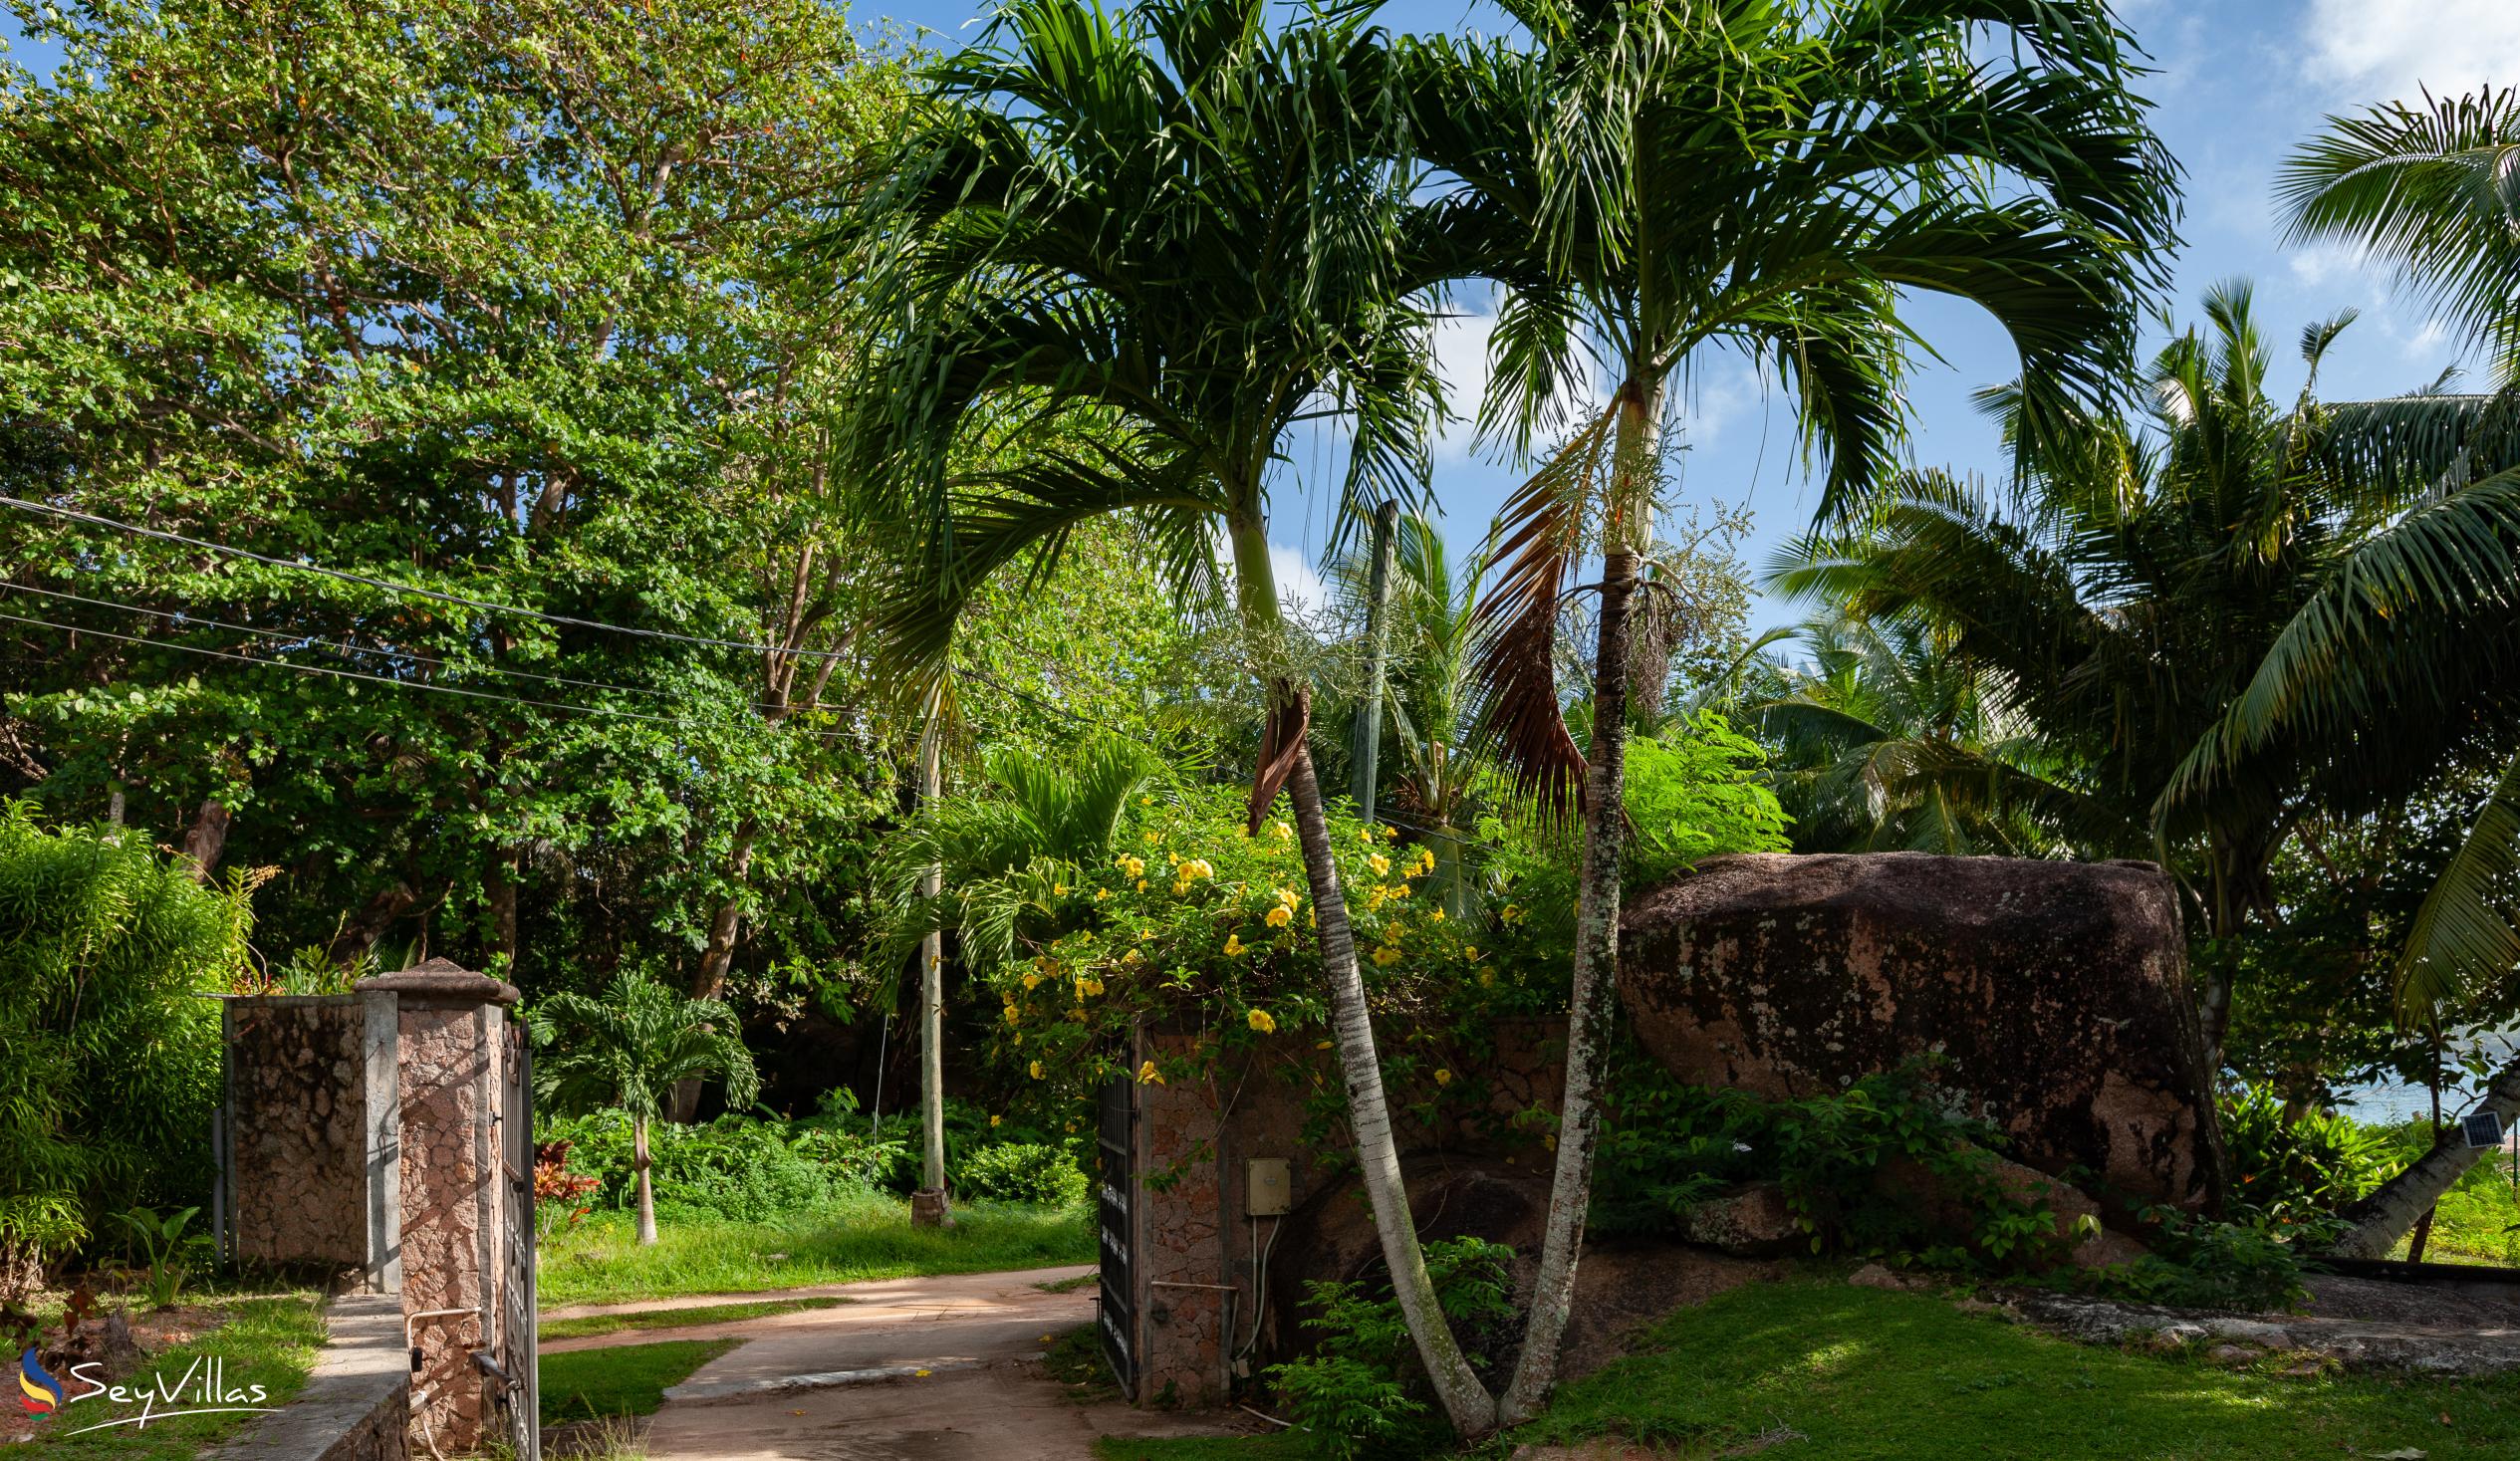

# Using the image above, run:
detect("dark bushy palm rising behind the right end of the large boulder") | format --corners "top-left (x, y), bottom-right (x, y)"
top-left (1774, 285), bottom-right (2489, 1063)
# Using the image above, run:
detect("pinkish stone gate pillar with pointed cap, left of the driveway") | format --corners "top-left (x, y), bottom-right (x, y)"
top-left (358, 960), bottom-right (517, 1453)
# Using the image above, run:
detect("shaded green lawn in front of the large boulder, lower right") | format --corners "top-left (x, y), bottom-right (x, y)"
top-left (1099, 1280), bottom-right (2520, 1461)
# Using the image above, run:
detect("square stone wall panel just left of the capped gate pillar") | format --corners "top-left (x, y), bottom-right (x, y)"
top-left (222, 995), bottom-right (400, 1290)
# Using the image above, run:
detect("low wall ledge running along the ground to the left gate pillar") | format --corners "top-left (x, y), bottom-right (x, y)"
top-left (204, 1295), bottom-right (410, 1461)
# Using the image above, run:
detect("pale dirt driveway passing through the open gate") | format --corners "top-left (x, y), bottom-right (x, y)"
top-left (610, 1267), bottom-right (1260, 1461)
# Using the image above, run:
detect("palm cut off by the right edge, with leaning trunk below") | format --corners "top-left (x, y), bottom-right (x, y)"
top-left (2207, 89), bottom-right (2520, 1257)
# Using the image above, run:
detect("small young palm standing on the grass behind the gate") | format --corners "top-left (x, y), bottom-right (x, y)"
top-left (532, 972), bottom-right (761, 1244)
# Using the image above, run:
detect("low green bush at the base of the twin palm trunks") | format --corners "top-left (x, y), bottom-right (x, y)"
top-left (1268, 1237), bottom-right (1520, 1461)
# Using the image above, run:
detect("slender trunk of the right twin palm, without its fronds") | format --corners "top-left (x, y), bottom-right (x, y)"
top-left (1502, 380), bottom-right (1660, 1426)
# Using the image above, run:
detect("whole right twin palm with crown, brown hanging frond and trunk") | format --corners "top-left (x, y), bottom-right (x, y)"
top-left (1411, 0), bottom-right (2177, 1418)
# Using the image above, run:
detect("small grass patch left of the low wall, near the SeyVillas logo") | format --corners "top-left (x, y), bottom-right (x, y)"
top-left (28, 1295), bottom-right (323, 1461)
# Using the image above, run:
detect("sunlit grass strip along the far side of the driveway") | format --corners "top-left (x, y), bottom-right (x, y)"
top-left (539, 1194), bottom-right (1094, 1333)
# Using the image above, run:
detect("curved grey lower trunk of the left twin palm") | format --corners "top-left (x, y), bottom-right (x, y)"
top-left (1285, 748), bottom-right (1497, 1438)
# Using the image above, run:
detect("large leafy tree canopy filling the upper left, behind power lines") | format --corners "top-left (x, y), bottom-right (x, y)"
top-left (0, 0), bottom-right (897, 993)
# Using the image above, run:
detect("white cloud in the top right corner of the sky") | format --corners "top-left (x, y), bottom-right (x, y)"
top-left (2301, 0), bottom-right (2520, 106)
